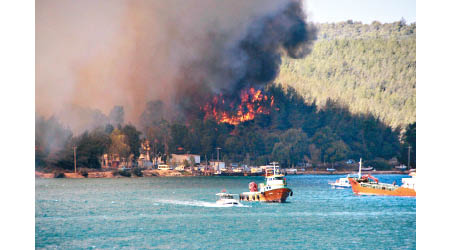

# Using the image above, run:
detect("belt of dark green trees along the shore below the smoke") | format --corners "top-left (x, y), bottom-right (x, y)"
top-left (36, 85), bottom-right (415, 169)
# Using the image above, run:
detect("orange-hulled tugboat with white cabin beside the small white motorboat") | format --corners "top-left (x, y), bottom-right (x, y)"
top-left (239, 162), bottom-right (293, 202)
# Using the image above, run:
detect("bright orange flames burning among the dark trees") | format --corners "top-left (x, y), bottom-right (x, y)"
top-left (202, 88), bottom-right (274, 125)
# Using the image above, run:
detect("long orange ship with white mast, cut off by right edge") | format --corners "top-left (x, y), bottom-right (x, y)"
top-left (348, 160), bottom-right (416, 197)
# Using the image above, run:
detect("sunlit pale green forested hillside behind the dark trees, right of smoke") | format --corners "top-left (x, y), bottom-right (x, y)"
top-left (276, 21), bottom-right (416, 129)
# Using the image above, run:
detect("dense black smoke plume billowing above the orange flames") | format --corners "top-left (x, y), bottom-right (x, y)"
top-left (176, 1), bottom-right (316, 112)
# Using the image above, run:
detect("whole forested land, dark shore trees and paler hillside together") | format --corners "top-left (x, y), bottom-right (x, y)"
top-left (36, 21), bottom-right (416, 169)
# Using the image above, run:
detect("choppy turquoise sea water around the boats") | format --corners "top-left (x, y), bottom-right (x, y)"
top-left (35, 175), bottom-right (416, 249)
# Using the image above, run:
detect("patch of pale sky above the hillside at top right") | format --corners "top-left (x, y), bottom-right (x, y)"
top-left (305, 0), bottom-right (416, 23)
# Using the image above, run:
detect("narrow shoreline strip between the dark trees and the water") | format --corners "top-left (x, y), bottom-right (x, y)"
top-left (35, 169), bottom-right (409, 179)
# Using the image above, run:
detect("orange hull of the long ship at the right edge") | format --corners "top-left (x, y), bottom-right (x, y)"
top-left (349, 178), bottom-right (416, 197)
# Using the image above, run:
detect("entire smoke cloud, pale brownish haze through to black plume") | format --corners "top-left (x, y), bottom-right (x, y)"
top-left (36, 0), bottom-right (314, 132)
